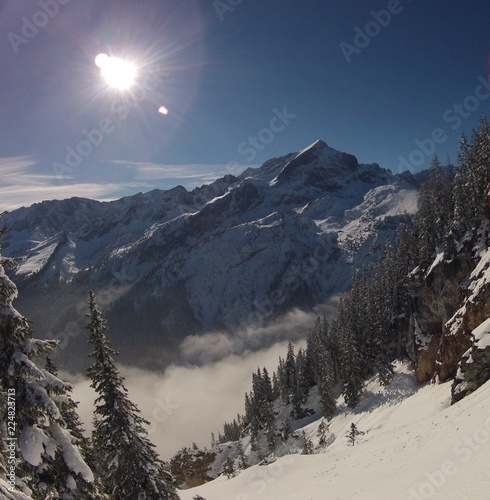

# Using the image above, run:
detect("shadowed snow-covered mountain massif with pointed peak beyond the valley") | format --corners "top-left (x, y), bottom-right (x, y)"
top-left (3, 141), bottom-right (418, 365)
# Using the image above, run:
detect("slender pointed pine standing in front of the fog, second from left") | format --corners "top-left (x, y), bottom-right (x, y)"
top-left (86, 291), bottom-right (179, 500)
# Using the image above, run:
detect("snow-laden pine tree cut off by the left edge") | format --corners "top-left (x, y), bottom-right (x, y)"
top-left (0, 245), bottom-right (94, 500)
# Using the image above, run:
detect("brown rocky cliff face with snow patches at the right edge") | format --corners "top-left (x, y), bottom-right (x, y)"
top-left (410, 238), bottom-right (490, 401)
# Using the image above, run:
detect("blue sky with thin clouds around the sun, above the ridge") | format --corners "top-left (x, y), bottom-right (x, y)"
top-left (0, 0), bottom-right (490, 208)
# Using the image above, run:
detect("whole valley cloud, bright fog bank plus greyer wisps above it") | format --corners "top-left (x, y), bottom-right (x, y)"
top-left (65, 300), bottom-right (336, 460)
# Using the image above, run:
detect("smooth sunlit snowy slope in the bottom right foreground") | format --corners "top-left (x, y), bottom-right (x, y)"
top-left (180, 365), bottom-right (490, 500)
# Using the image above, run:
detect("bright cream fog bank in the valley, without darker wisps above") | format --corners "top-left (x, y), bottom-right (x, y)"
top-left (67, 342), bottom-right (287, 460)
